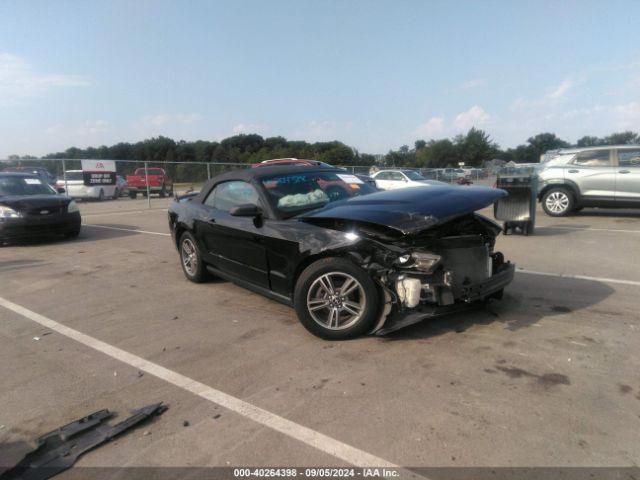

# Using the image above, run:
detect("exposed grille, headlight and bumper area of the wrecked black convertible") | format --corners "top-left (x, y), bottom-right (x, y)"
top-left (376, 214), bottom-right (515, 334)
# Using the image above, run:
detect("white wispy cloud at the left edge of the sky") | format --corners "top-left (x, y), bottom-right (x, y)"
top-left (0, 53), bottom-right (89, 105)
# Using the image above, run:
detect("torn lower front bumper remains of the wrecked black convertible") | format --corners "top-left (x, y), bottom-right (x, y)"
top-left (372, 262), bottom-right (515, 335)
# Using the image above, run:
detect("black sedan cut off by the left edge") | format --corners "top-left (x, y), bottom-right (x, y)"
top-left (0, 172), bottom-right (81, 241)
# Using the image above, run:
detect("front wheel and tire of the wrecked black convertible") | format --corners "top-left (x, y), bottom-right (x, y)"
top-left (294, 258), bottom-right (380, 340)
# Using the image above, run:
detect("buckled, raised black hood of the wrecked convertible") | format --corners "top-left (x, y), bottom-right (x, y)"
top-left (298, 185), bottom-right (507, 235)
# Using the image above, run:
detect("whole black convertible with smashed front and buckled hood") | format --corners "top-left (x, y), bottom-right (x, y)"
top-left (169, 166), bottom-right (514, 339)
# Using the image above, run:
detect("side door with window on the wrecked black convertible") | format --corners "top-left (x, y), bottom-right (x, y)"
top-left (200, 180), bottom-right (269, 288)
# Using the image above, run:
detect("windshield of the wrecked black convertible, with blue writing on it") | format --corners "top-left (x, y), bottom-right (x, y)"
top-left (261, 172), bottom-right (376, 217)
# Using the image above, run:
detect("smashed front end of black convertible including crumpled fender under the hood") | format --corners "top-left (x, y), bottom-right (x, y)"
top-left (302, 213), bottom-right (515, 335)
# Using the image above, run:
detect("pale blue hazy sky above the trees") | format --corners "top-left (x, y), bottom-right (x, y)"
top-left (0, 0), bottom-right (640, 158)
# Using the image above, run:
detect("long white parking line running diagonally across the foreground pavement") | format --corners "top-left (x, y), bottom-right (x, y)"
top-left (0, 297), bottom-right (404, 470)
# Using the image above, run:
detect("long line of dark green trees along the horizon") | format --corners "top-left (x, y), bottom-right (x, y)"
top-left (6, 128), bottom-right (640, 168)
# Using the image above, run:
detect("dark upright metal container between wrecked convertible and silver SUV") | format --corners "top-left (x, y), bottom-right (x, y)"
top-left (493, 169), bottom-right (538, 235)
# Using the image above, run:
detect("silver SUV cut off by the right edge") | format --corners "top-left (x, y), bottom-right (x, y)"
top-left (538, 145), bottom-right (640, 217)
